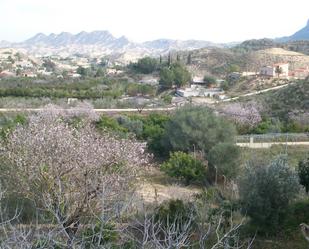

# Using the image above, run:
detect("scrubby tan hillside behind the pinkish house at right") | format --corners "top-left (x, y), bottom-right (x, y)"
top-left (180, 47), bottom-right (309, 76)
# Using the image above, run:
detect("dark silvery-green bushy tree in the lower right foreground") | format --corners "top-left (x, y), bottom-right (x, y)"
top-left (240, 156), bottom-right (299, 233)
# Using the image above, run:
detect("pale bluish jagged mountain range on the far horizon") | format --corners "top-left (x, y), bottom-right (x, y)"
top-left (0, 31), bottom-right (223, 59)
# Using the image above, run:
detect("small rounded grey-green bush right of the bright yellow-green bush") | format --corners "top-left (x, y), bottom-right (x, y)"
top-left (207, 143), bottom-right (240, 178)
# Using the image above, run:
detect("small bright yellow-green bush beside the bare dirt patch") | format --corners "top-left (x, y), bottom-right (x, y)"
top-left (161, 152), bottom-right (207, 184)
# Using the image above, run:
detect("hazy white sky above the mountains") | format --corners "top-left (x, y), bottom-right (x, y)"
top-left (0, 0), bottom-right (309, 42)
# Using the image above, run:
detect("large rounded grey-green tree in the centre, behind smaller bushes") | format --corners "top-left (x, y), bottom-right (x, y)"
top-left (162, 106), bottom-right (236, 154)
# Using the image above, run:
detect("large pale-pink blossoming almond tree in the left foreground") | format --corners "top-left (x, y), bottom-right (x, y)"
top-left (2, 104), bottom-right (148, 244)
